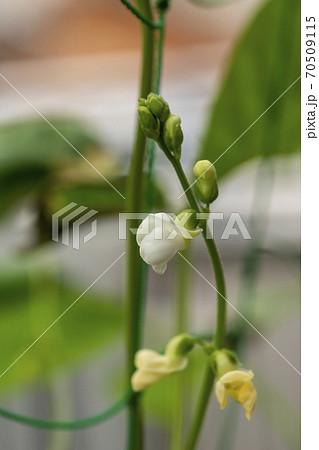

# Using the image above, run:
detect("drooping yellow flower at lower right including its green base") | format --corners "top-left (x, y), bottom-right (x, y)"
top-left (211, 349), bottom-right (257, 420)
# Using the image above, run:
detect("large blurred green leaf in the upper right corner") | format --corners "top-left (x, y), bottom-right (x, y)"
top-left (200, 0), bottom-right (300, 177)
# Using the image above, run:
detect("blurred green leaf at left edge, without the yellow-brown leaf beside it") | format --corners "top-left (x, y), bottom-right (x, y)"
top-left (0, 118), bottom-right (98, 215)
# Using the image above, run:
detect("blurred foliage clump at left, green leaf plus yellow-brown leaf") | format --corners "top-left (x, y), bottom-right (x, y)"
top-left (0, 118), bottom-right (164, 243)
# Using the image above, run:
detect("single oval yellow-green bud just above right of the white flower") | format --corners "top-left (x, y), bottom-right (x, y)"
top-left (193, 160), bottom-right (218, 203)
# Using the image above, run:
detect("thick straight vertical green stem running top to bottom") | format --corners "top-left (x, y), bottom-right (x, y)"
top-left (126, 0), bottom-right (154, 450)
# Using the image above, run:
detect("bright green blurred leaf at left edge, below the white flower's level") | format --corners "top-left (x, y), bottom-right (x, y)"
top-left (0, 258), bottom-right (123, 390)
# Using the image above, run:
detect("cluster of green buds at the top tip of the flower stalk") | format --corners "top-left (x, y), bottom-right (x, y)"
top-left (137, 93), bottom-right (184, 159)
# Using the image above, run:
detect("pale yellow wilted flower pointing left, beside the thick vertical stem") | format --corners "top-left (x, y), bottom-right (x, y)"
top-left (131, 349), bottom-right (188, 392)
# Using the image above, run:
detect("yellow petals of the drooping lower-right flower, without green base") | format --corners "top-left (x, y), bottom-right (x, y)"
top-left (215, 370), bottom-right (257, 420)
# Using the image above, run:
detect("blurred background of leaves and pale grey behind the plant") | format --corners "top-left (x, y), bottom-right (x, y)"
top-left (0, 0), bottom-right (300, 450)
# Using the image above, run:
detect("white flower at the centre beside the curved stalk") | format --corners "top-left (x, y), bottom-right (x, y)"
top-left (136, 213), bottom-right (202, 275)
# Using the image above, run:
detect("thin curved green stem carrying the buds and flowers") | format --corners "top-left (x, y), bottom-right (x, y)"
top-left (159, 156), bottom-right (226, 450)
